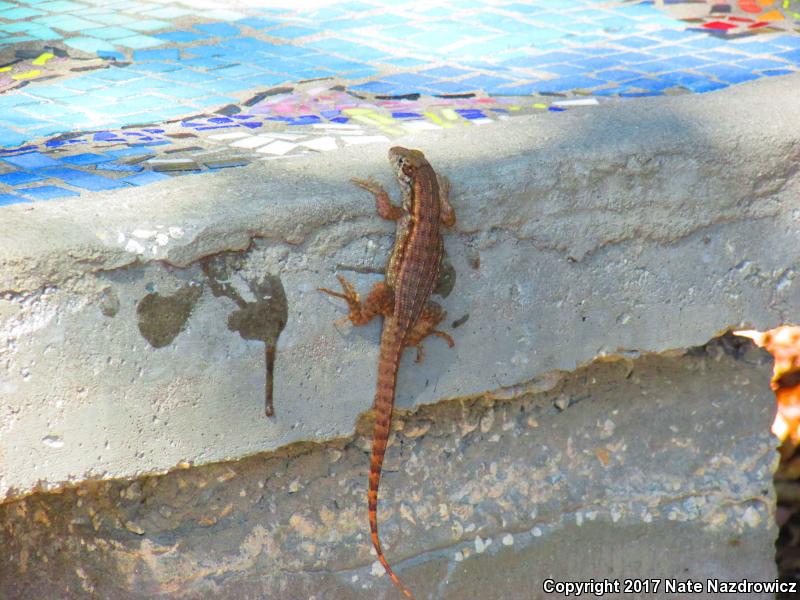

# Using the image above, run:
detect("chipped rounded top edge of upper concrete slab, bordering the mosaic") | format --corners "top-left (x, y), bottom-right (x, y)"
top-left (0, 74), bottom-right (800, 294)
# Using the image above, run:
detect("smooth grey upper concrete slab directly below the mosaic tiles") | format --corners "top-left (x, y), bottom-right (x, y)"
top-left (0, 76), bottom-right (800, 497)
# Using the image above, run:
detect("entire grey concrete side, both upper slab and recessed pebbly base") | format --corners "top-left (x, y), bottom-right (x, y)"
top-left (0, 72), bottom-right (800, 598)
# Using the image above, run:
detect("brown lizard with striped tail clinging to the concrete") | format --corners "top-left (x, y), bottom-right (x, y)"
top-left (320, 147), bottom-right (456, 599)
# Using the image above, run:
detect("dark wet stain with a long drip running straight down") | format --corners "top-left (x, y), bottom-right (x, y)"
top-left (203, 252), bottom-right (289, 417)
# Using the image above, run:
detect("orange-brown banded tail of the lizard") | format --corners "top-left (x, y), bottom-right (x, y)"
top-left (367, 322), bottom-right (414, 600)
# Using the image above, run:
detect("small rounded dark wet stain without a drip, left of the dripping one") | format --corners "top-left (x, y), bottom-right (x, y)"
top-left (136, 286), bottom-right (203, 348)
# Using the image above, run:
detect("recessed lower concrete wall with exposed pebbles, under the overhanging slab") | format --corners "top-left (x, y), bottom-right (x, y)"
top-left (0, 336), bottom-right (777, 600)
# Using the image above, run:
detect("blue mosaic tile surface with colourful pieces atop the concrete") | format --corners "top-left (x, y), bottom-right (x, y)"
top-left (0, 0), bottom-right (800, 206)
